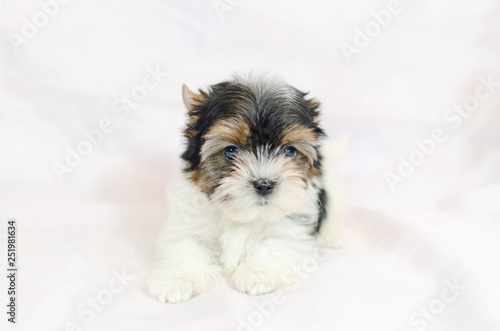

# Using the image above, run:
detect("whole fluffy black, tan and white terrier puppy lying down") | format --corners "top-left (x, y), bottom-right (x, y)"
top-left (146, 76), bottom-right (338, 303)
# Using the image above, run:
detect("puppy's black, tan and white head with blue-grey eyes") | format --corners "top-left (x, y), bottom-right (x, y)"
top-left (182, 78), bottom-right (323, 222)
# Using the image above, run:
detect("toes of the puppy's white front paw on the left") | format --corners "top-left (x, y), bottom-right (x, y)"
top-left (146, 278), bottom-right (195, 303)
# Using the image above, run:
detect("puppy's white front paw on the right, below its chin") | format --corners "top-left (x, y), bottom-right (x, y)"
top-left (232, 265), bottom-right (294, 295)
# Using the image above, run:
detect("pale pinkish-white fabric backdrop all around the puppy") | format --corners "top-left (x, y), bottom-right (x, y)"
top-left (0, 0), bottom-right (500, 331)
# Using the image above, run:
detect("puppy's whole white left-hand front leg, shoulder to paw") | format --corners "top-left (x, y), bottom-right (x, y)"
top-left (145, 175), bottom-right (220, 303)
